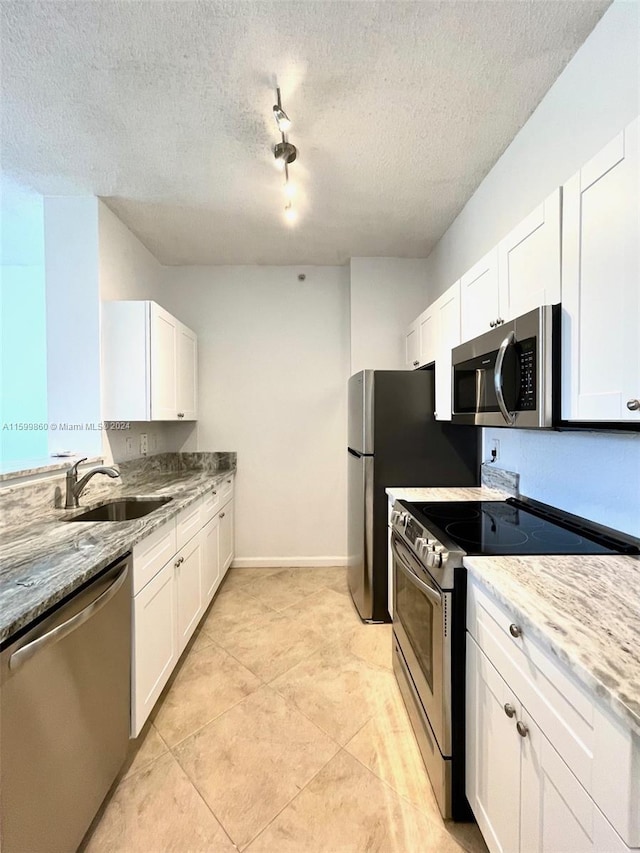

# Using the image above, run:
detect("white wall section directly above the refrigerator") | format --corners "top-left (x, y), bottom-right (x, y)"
top-left (350, 258), bottom-right (429, 374)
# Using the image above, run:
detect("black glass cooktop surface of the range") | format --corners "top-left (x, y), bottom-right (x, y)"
top-left (410, 498), bottom-right (638, 556)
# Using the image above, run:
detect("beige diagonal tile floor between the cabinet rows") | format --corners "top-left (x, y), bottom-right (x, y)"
top-left (83, 568), bottom-right (486, 853)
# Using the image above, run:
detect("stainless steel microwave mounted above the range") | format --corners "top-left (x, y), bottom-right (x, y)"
top-left (451, 305), bottom-right (560, 429)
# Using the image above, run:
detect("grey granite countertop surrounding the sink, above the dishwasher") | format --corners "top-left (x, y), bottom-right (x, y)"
top-left (0, 468), bottom-right (235, 643)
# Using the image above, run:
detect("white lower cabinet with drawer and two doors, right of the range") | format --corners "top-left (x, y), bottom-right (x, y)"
top-left (466, 582), bottom-right (639, 853)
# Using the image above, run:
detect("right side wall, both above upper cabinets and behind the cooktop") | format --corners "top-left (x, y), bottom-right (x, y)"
top-left (427, 0), bottom-right (640, 535)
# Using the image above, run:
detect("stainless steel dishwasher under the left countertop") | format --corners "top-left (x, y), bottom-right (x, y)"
top-left (0, 556), bottom-right (131, 853)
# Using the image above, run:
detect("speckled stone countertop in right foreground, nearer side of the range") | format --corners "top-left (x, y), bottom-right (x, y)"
top-left (464, 555), bottom-right (640, 735)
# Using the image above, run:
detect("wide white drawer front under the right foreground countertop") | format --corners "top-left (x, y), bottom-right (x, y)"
top-left (467, 581), bottom-right (640, 846)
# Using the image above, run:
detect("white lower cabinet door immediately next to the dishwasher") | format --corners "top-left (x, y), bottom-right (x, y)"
top-left (131, 560), bottom-right (179, 737)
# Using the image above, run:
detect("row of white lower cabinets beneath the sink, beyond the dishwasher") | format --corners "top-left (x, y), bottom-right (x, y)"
top-left (131, 477), bottom-right (234, 737)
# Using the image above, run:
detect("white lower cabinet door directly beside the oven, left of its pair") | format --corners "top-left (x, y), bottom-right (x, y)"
top-left (466, 633), bottom-right (521, 853)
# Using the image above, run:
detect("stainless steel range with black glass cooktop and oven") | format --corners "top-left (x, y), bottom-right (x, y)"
top-left (391, 498), bottom-right (640, 820)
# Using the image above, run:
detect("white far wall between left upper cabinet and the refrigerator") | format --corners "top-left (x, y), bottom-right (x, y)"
top-left (158, 266), bottom-right (349, 566)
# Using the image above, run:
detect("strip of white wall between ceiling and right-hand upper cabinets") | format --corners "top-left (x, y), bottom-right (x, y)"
top-left (426, 0), bottom-right (640, 302)
